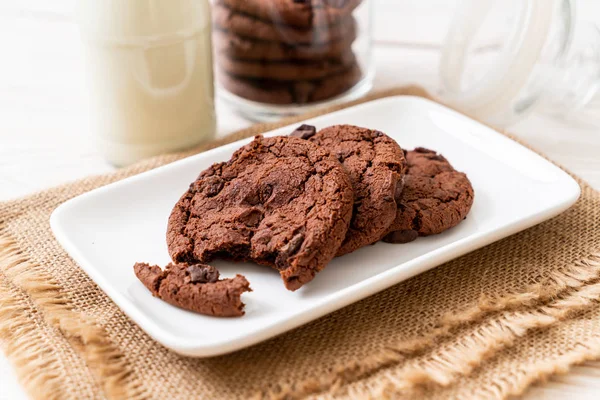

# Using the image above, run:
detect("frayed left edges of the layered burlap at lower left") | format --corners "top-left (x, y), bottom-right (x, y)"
top-left (0, 228), bottom-right (148, 400)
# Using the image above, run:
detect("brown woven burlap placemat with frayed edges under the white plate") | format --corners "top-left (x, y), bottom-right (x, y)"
top-left (0, 87), bottom-right (600, 399)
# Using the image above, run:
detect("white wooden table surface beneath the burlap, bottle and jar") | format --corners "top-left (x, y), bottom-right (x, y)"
top-left (0, 0), bottom-right (600, 400)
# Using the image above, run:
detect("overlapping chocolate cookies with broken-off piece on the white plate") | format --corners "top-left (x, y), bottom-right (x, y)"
top-left (134, 125), bottom-right (474, 316)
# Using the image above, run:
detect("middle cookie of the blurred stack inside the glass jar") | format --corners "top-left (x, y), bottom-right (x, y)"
top-left (213, 29), bottom-right (356, 64)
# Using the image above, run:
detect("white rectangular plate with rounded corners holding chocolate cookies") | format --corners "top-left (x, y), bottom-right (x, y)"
top-left (51, 96), bottom-right (580, 357)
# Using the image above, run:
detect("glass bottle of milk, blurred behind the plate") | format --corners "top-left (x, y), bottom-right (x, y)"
top-left (77, 0), bottom-right (216, 166)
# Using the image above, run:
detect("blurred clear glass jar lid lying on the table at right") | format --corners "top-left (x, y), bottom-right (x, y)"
top-left (440, 0), bottom-right (600, 126)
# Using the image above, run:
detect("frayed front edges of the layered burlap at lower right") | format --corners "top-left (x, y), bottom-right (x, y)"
top-left (264, 254), bottom-right (600, 400)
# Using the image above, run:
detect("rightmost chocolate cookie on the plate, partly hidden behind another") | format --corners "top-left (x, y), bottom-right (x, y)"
top-left (383, 147), bottom-right (475, 243)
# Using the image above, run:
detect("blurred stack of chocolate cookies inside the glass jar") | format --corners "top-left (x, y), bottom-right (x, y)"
top-left (213, 0), bottom-right (361, 104)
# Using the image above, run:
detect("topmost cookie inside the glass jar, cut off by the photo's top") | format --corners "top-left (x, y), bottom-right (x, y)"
top-left (217, 0), bottom-right (362, 28)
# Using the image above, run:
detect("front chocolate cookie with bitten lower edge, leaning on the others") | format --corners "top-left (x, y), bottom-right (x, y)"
top-left (167, 136), bottom-right (353, 290)
